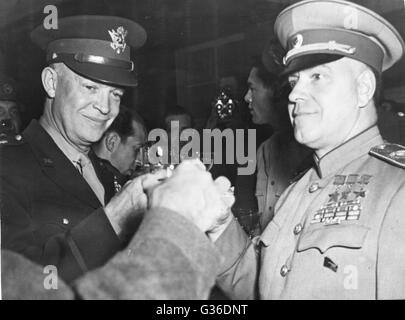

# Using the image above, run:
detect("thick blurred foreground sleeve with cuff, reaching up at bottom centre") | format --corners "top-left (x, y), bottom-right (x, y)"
top-left (75, 208), bottom-right (221, 299)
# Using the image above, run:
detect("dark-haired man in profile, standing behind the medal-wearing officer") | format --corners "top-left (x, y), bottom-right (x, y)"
top-left (245, 56), bottom-right (312, 235)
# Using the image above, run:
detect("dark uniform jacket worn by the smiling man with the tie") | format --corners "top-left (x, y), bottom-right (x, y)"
top-left (0, 120), bottom-right (122, 282)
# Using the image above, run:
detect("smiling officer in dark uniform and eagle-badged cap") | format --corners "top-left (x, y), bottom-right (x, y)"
top-left (0, 16), bottom-right (162, 282)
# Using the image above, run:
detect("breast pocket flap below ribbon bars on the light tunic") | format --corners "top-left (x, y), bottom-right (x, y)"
top-left (297, 224), bottom-right (370, 254)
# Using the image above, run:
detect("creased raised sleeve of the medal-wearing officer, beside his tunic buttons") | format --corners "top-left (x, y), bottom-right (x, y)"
top-left (215, 220), bottom-right (259, 300)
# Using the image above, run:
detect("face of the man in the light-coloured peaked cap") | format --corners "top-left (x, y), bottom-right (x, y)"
top-left (288, 58), bottom-right (361, 156)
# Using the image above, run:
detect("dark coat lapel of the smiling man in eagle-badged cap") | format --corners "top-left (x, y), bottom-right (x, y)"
top-left (23, 120), bottom-right (101, 209)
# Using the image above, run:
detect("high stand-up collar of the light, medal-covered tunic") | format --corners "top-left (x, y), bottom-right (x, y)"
top-left (314, 125), bottom-right (383, 178)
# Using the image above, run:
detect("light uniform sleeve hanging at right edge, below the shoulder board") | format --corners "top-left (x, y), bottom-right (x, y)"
top-left (376, 184), bottom-right (405, 299)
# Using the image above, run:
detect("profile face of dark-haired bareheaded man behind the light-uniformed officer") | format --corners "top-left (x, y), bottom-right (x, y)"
top-left (245, 67), bottom-right (273, 124)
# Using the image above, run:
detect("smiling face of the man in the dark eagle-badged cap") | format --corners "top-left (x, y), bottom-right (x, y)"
top-left (52, 65), bottom-right (124, 148)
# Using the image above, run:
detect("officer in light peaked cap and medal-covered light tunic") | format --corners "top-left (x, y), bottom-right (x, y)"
top-left (211, 0), bottom-right (405, 299)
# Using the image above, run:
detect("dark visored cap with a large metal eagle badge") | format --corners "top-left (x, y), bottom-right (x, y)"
top-left (31, 15), bottom-right (146, 86)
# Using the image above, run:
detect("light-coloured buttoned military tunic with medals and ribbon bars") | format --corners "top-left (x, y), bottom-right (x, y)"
top-left (217, 127), bottom-right (405, 299)
